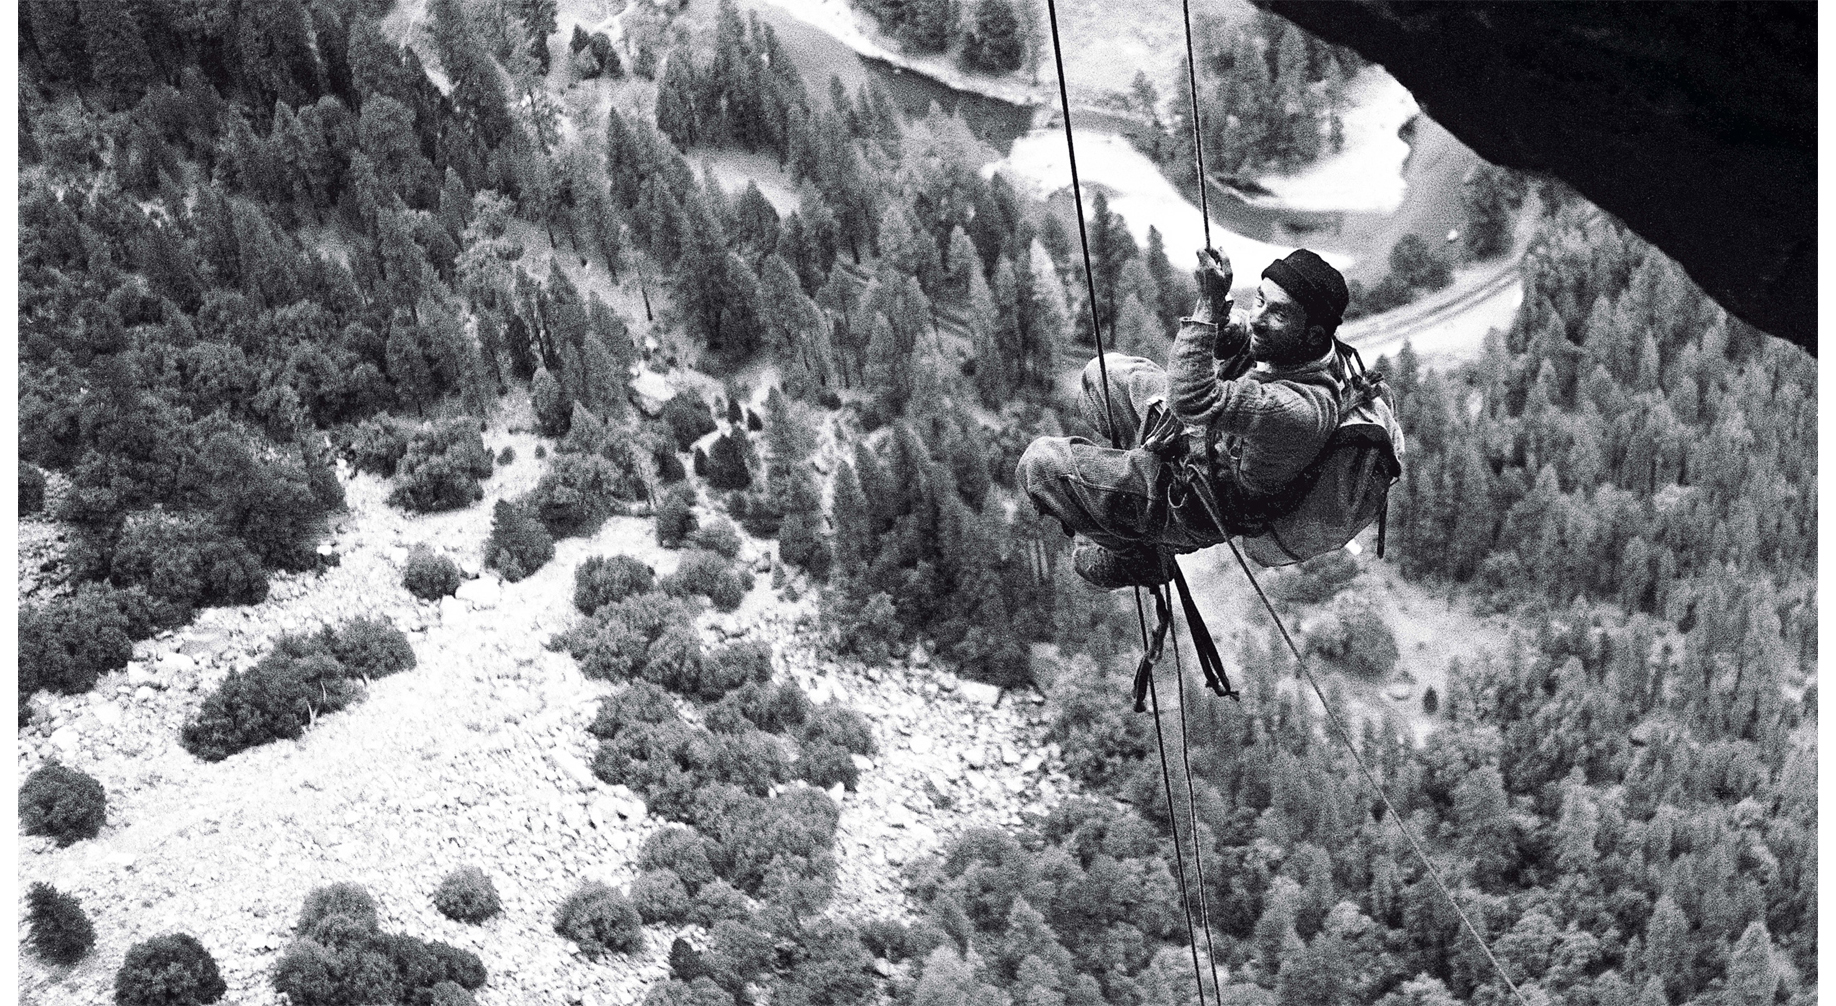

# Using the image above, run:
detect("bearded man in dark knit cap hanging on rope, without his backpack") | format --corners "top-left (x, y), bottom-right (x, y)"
top-left (1017, 248), bottom-right (1349, 589)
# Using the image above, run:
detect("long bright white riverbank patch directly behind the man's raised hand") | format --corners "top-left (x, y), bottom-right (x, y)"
top-left (982, 129), bottom-right (1355, 290)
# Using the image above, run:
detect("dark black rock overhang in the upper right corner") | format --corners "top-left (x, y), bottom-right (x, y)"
top-left (1256, 0), bottom-right (1818, 354)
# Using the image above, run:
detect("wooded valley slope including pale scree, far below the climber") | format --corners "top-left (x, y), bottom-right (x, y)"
top-left (17, 0), bottom-right (1818, 1006)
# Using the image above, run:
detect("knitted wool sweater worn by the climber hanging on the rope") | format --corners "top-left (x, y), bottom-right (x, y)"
top-left (1168, 312), bottom-right (1342, 496)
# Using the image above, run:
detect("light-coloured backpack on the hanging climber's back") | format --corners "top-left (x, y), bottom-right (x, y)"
top-left (1243, 340), bottom-right (1403, 565)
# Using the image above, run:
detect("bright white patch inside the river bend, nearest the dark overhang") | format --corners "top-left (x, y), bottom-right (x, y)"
top-left (1247, 66), bottom-right (1421, 215)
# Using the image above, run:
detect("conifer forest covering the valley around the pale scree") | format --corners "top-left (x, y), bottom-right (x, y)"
top-left (18, 0), bottom-right (1818, 1006)
